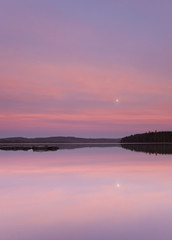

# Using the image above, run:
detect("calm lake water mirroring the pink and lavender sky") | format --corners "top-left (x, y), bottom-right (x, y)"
top-left (0, 147), bottom-right (172, 240)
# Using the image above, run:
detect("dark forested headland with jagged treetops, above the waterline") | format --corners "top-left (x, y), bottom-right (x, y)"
top-left (121, 131), bottom-right (172, 143)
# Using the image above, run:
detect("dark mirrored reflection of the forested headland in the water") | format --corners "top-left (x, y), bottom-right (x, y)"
top-left (121, 143), bottom-right (172, 154)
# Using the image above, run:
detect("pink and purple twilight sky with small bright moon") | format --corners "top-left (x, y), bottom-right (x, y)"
top-left (0, 0), bottom-right (172, 138)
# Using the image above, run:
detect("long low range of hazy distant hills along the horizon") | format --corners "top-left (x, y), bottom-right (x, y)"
top-left (0, 137), bottom-right (120, 143)
